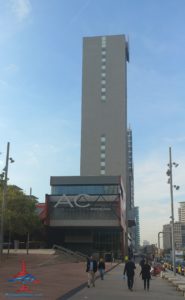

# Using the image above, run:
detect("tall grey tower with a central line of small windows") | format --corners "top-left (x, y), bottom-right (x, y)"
top-left (80, 35), bottom-right (129, 190)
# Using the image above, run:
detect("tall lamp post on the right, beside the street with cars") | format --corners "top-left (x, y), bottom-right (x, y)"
top-left (166, 147), bottom-right (179, 276)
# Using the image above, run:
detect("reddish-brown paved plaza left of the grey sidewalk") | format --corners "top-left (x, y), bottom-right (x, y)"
top-left (0, 251), bottom-right (114, 300)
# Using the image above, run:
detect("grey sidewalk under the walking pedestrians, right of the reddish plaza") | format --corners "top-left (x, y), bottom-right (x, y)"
top-left (64, 264), bottom-right (184, 300)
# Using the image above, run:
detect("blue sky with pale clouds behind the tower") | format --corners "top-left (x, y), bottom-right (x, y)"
top-left (0, 0), bottom-right (185, 243)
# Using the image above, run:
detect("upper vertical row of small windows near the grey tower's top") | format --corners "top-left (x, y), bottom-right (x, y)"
top-left (101, 36), bottom-right (106, 101)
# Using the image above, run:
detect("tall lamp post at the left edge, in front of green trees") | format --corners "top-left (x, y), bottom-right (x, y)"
top-left (0, 142), bottom-right (14, 259)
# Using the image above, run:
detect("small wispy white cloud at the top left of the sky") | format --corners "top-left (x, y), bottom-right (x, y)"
top-left (11, 0), bottom-right (32, 21)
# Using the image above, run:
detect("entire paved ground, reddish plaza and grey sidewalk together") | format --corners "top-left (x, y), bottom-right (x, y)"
top-left (0, 254), bottom-right (184, 300)
